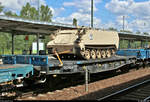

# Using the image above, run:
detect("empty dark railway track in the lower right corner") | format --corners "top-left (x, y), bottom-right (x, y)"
top-left (97, 79), bottom-right (150, 102)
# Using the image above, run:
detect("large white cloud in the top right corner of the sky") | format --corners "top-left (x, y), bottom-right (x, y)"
top-left (105, 0), bottom-right (150, 18)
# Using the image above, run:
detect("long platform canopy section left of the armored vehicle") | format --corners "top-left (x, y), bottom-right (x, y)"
top-left (0, 16), bottom-right (77, 35)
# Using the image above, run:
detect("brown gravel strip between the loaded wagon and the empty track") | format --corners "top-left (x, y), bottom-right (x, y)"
top-left (18, 68), bottom-right (150, 100)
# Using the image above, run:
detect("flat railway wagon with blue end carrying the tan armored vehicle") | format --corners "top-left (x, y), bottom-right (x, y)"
top-left (0, 55), bottom-right (136, 74)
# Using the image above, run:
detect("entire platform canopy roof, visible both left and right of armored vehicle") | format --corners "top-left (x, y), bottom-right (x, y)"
top-left (0, 16), bottom-right (150, 41)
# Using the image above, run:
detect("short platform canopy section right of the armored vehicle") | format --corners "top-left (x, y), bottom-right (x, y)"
top-left (118, 32), bottom-right (150, 41)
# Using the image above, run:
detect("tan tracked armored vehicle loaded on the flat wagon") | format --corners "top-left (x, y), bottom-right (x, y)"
top-left (47, 28), bottom-right (119, 59)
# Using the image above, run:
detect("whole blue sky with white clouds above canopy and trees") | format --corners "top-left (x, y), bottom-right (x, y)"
top-left (0, 0), bottom-right (150, 33)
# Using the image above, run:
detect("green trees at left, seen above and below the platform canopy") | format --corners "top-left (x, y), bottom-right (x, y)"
top-left (0, 3), bottom-right (53, 54)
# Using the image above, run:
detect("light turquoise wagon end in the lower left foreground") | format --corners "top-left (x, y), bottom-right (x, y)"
top-left (0, 64), bottom-right (33, 83)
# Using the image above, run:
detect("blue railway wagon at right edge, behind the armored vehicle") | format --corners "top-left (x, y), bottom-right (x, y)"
top-left (116, 49), bottom-right (150, 60)
